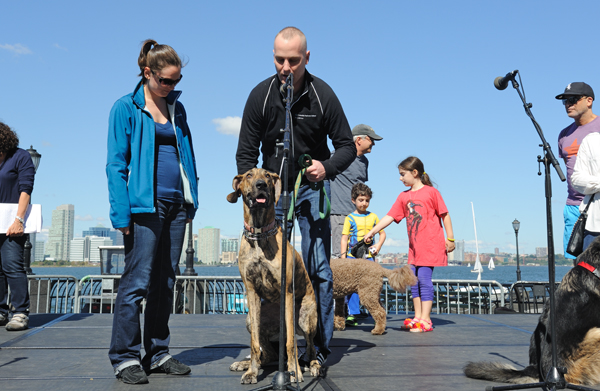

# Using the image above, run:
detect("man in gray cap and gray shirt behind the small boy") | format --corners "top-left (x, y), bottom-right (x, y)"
top-left (329, 124), bottom-right (383, 258)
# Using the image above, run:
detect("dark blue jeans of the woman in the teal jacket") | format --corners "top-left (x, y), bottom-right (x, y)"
top-left (108, 201), bottom-right (186, 371)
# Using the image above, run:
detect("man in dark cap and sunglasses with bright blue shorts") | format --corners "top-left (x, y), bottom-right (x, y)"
top-left (556, 82), bottom-right (600, 259)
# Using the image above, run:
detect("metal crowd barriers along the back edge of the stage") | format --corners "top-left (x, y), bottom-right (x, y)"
top-left (9, 275), bottom-right (548, 314)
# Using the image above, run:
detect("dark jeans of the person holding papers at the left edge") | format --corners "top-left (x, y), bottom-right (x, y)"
top-left (0, 234), bottom-right (29, 316)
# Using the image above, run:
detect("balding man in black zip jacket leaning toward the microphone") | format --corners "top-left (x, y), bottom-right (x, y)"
top-left (236, 27), bottom-right (356, 363)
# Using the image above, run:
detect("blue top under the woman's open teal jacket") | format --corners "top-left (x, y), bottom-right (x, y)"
top-left (155, 121), bottom-right (183, 204)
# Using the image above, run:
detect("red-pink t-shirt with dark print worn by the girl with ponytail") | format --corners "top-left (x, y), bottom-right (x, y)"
top-left (388, 186), bottom-right (448, 266)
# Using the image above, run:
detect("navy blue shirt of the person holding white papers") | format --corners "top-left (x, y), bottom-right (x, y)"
top-left (0, 148), bottom-right (35, 204)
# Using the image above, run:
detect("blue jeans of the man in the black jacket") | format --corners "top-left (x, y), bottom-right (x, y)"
top-left (275, 181), bottom-right (333, 354)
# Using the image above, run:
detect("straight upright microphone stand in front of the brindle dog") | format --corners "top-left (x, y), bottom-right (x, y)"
top-left (251, 73), bottom-right (299, 391)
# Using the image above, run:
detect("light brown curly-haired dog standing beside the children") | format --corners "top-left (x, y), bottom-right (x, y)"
top-left (330, 258), bottom-right (417, 335)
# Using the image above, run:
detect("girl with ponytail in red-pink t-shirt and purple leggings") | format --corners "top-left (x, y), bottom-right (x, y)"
top-left (364, 156), bottom-right (455, 333)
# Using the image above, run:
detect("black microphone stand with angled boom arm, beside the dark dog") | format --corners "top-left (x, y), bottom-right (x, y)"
top-left (485, 71), bottom-right (594, 391)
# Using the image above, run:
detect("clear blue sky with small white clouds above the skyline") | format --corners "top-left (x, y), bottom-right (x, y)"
top-left (0, 0), bottom-right (600, 253)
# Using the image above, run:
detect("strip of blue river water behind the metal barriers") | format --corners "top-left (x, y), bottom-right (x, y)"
top-left (32, 265), bottom-right (571, 284)
